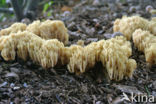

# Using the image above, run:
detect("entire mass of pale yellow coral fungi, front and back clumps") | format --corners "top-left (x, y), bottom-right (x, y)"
top-left (0, 16), bottom-right (149, 80)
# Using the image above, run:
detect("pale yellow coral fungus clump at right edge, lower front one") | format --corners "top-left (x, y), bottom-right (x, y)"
top-left (133, 29), bottom-right (156, 65)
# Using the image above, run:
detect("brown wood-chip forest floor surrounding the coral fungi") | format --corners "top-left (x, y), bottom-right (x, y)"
top-left (0, 0), bottom-right (156, 104)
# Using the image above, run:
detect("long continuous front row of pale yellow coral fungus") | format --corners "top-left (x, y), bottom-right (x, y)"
top-left (0, 31), bottom-right (136, 80)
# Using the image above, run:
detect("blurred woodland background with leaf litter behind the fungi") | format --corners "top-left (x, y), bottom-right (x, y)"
top-left (0, 0), bottom-right (156, 43)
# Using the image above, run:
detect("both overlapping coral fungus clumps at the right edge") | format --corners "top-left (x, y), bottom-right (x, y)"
top-left (113, 16), bottom-right (156, 65)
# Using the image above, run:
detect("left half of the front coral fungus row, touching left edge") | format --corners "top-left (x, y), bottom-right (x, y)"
top-left (0, 31), bottom-right (64, 68)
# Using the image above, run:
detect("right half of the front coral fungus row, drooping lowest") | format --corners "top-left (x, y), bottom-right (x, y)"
top-left (68, 36), bottom-right (136, 80)
